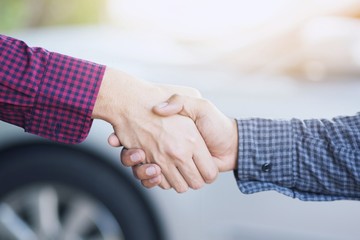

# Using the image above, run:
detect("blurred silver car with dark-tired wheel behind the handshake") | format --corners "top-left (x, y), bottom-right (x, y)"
top-left (0, 27), bottom-right (360, 240)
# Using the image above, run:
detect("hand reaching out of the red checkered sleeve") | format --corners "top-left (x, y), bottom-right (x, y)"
top-left (93, 69), bottom-right (218, 192)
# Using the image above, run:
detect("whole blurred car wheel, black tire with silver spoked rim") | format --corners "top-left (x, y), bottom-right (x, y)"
top-left (0, 143), bottom-right (163, 240)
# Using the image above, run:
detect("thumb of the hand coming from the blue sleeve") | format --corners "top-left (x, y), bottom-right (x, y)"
top-left (153, 94), bottom-right (196, 121)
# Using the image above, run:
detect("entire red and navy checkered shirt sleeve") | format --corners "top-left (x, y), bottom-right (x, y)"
top-left (0, 35), bottom-right (105, 144)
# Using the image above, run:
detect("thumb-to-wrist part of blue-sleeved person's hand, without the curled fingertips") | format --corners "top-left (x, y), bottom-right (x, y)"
top-left (153, 95), bottom-right (238, 172)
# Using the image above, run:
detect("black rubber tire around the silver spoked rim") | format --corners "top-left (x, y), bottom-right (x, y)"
top-left (0, 143), bottom-right (163, 240)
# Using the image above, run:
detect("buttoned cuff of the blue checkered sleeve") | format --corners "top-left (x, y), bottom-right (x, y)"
top-left (235, 119), bottom-right (297, 197)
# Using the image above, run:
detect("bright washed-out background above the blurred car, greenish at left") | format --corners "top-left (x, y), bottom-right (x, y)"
top-left (0, 0), bottom-right (360, 81)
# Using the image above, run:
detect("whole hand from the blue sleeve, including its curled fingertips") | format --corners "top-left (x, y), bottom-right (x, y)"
top-left (109, 95), bottom-right (238, 187)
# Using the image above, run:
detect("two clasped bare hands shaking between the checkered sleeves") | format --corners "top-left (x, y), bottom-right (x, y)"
top-left (92, 68), bottom-right (238, 193)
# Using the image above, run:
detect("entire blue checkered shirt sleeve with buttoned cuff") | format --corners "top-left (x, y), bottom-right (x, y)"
top-left (235, 113), bottom-right (360, 201)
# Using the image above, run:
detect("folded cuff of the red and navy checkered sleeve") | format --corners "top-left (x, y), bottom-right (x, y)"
top-left (25, 53), bottom-right (105, 144)
